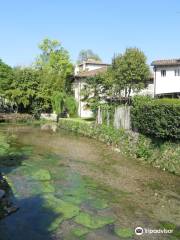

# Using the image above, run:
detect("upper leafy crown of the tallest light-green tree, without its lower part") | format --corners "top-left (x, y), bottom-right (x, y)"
top-left (35, 38), bottom-right (73, 95)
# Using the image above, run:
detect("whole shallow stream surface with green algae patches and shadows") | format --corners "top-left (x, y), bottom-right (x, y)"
top-left (0, 125), bottom-right (180, 240)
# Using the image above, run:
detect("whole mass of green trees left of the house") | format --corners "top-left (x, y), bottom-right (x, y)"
top-left (0, 39), bottom-right (76, 118)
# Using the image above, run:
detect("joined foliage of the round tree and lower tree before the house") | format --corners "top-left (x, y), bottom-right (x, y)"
top-left (81, 48), bottom-right (150, 115)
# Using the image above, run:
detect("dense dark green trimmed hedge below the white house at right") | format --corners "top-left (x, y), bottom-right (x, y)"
top-left (131, 97), bottom-right (180, 139)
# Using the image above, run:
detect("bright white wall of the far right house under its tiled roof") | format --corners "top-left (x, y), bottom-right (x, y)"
top-left (154, 66), bottom-right (180, 94)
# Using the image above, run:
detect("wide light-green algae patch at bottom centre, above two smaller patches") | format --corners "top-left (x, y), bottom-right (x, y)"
top-left (74, 212), bottom-right (115, 229)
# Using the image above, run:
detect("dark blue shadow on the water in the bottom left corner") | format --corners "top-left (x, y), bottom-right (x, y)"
top-left (0, 196), bottom-right (59, 240)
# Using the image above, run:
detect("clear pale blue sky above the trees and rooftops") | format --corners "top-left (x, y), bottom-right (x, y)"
top-left (0, 0), bottom-right (180, 66)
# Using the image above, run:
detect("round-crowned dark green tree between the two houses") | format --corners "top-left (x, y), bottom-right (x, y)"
top-left (111, 48), bottom-right (150, 99)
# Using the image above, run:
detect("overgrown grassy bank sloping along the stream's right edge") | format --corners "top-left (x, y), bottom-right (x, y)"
top-left (59, 119), bottom-right (180, 175)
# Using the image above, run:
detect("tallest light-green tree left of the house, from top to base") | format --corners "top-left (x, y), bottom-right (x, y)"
top-left (35, 38), bottom-right (73, 112)
